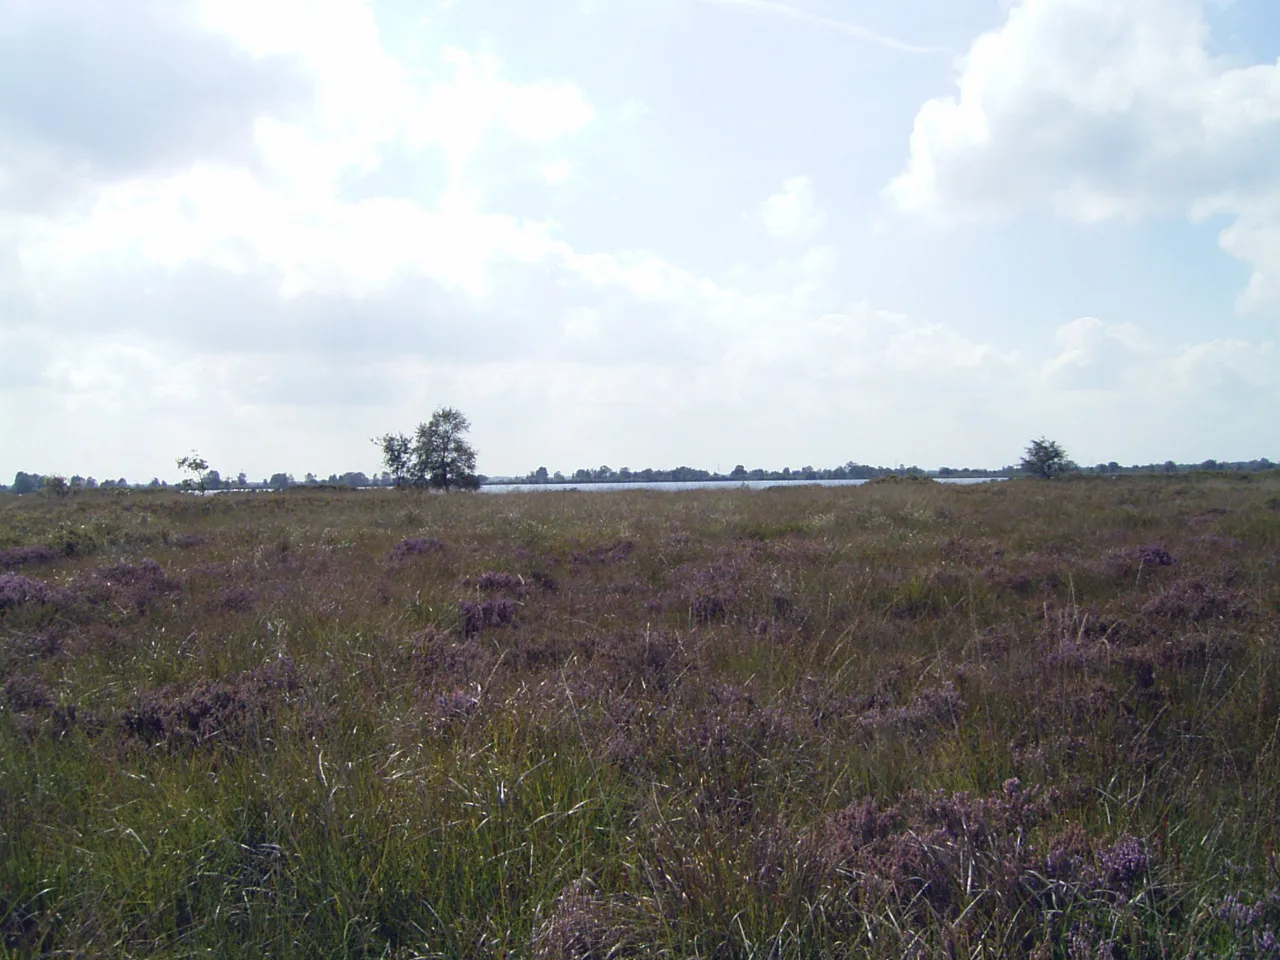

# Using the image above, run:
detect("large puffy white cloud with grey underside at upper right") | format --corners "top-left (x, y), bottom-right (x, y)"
top-left (886, 0), bottom-right (1280, 305)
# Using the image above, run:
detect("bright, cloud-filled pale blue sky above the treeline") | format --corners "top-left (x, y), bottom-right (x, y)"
top-left (0, 0), bottom-right (1280, 481)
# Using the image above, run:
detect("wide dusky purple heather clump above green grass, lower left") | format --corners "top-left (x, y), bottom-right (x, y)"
top-left (120, 659), bottom-right (302, 751)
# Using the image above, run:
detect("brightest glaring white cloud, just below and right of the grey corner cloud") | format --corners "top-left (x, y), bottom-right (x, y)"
top-left (20, 35), bottom-right (594, 297)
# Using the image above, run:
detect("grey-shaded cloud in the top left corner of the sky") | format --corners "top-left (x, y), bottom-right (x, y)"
top-left (0, 0), bottom-right (312, 212)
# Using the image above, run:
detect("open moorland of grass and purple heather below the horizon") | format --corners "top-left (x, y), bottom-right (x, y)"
top-left (0, 475), bottom-right (1280, 960)
